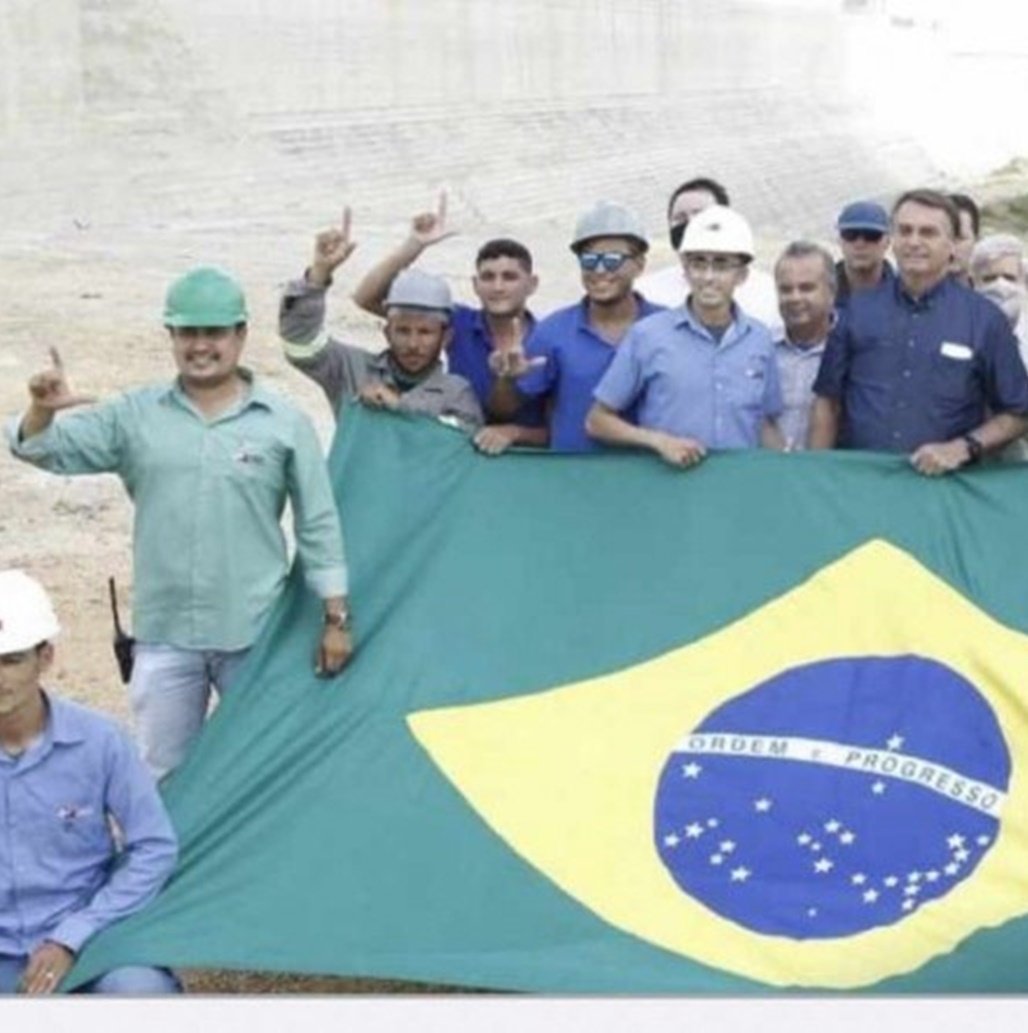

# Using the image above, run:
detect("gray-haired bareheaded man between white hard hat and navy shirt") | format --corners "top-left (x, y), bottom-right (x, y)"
top-left (775, 241), bottom-right (838, 451)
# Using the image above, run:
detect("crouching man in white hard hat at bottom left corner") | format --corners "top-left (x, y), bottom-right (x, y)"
top-left (0, 570), bottom-right (180, 995)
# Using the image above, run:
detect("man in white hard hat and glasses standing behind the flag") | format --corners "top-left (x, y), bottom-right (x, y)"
top-left (586, 205), bottom-right (783, 467)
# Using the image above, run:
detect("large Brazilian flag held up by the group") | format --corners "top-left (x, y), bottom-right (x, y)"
top-left (68, 411), bottom-right (1028, 994)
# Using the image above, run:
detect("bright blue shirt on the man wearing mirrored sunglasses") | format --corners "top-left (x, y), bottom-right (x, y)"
top-left (518, 294), bottom-right (664, 451)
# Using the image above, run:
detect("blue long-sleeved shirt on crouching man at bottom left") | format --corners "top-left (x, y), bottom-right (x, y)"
top-left (0, 696), bottom-right (178, 957)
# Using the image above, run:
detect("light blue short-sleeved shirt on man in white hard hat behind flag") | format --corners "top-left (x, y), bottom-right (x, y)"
top-left (595, 305), bottom-right (782, 448)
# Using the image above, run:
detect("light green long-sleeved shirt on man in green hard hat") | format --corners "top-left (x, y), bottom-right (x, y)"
top-left (7, 371), bottom-right (346, 650)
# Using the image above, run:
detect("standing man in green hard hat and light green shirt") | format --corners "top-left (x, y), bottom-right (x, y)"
top-left (7, 267), bottom-right (352, 778)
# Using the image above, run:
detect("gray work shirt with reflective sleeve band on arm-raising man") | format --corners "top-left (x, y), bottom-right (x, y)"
top-left (279, 279), bottom-right (484, 430)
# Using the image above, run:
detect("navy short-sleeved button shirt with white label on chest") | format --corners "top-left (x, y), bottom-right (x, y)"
top-left (814, 276), bottom-right (1028, 452)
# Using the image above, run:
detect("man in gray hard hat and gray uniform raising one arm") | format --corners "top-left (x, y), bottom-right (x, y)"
top-left (279, 211), bottom-right (482, 431)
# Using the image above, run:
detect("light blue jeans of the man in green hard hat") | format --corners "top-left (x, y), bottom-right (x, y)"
top-left (128, 643), bottom-right (249, 779)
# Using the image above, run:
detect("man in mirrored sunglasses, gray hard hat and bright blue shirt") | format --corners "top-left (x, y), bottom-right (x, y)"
top-left (489, 201), bottom-right (661, 451)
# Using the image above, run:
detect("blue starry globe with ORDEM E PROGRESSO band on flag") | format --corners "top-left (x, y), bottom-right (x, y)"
top-left (654, 656), bottom-right (1010, 940)
